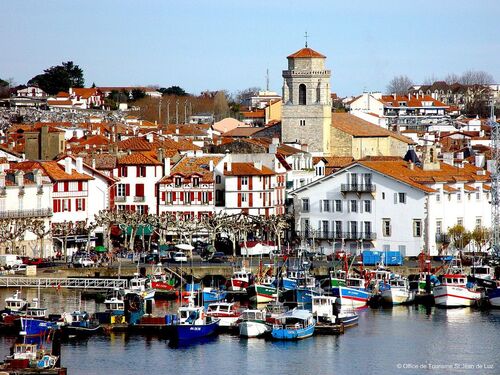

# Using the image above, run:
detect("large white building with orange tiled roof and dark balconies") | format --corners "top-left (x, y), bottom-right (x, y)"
top-left (292, 148), bottom-right (491, 256)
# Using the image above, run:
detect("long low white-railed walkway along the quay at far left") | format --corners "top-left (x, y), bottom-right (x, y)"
top-left (0, 276), bottom-right (128, 289)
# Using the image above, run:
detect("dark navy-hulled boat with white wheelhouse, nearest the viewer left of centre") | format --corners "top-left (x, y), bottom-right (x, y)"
top-left (173, 297), bottom-right (220, 341)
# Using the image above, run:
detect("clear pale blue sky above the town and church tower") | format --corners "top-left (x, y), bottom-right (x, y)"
top-left (0, 0), bottom-right (500, 96)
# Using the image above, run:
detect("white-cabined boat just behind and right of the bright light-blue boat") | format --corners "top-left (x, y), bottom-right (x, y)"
top-left (311, 295), bottom-right (359, 328)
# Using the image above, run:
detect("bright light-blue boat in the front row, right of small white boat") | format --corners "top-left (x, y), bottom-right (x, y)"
top-left (271, 309), bottom-right (316, 340)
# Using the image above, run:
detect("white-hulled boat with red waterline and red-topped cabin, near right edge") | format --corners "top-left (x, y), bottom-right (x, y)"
top-left (433, 273), bottom-right (484, 307)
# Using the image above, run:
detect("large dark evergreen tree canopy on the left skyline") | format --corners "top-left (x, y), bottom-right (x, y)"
top-left (28, 61), bottom-right (85, 95)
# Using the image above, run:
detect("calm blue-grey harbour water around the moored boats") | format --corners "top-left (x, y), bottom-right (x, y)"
top-left (0, 289), bottom-right (500, 375)
